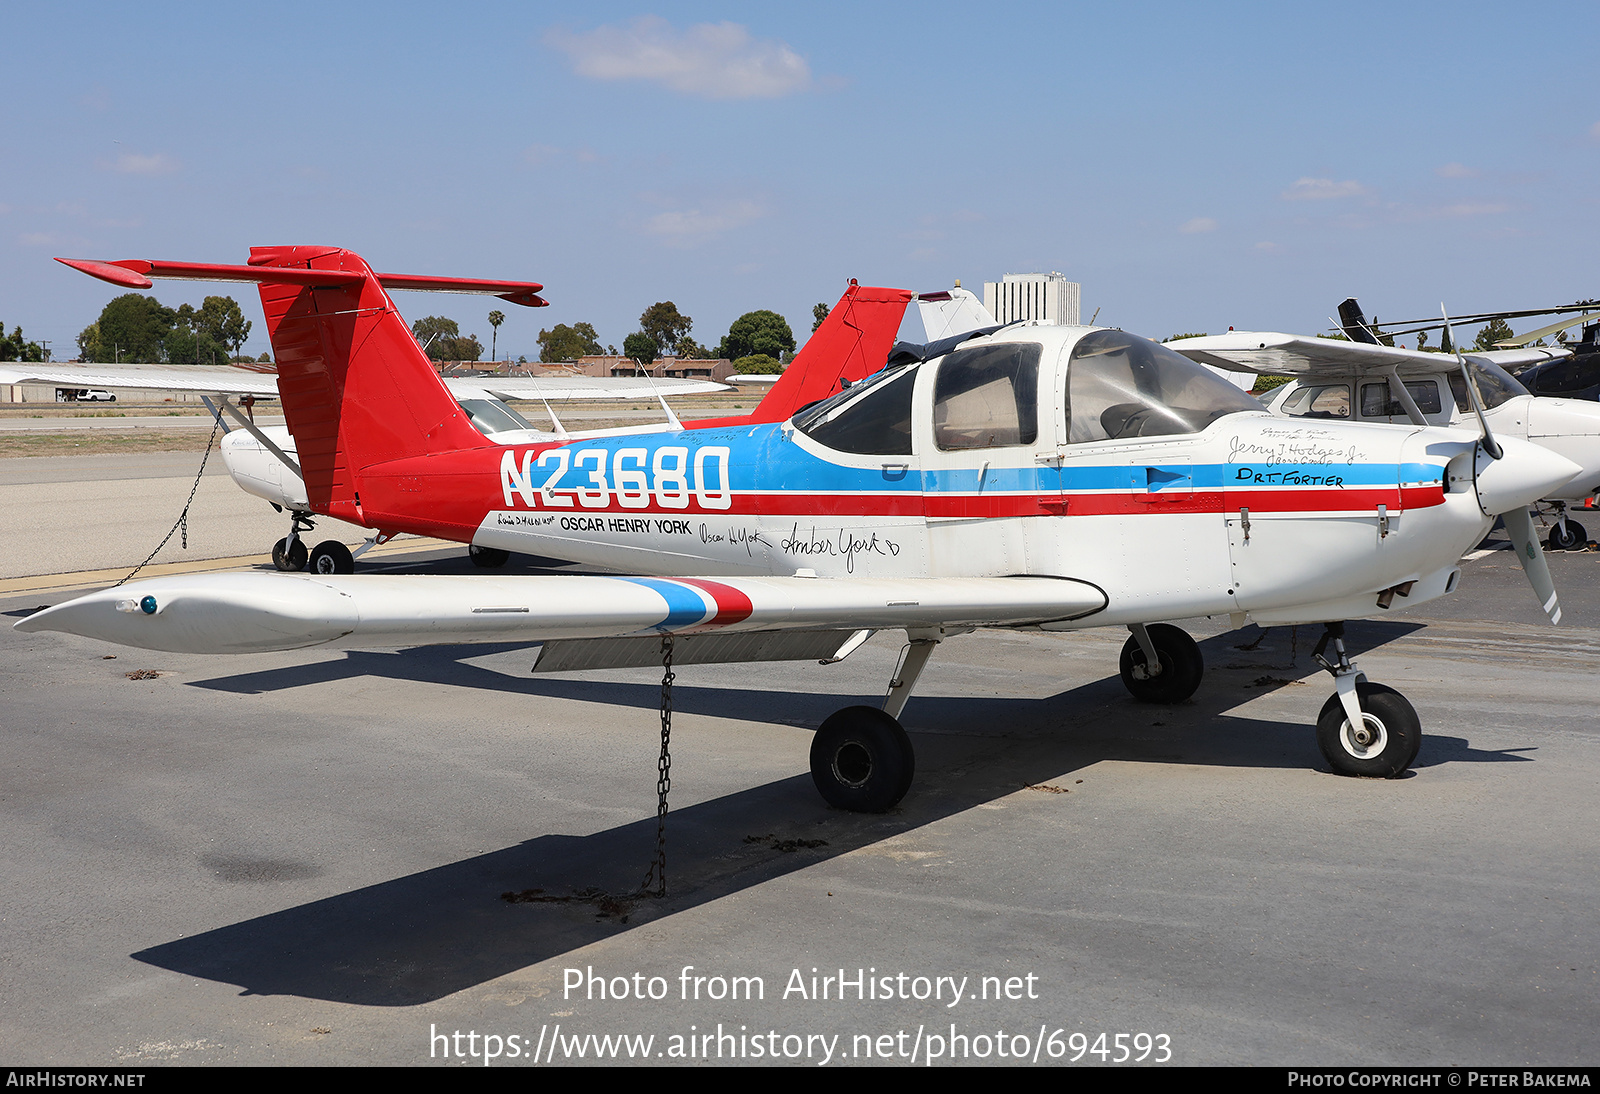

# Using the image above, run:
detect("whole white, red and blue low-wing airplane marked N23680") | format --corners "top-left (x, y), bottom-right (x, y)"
top-left (16, 248), bottom-right (1578, 811)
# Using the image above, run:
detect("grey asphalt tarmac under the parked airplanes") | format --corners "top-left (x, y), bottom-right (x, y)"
top-left (0, 457), bottom-right (1600, 1067)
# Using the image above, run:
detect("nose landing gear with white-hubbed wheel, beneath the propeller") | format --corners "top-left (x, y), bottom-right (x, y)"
top-left (1312, 622), bottom-right (1422, 779)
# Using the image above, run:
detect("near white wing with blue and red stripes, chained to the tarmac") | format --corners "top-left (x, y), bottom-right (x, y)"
top-left (16, 573), bottom-right (1107, 667)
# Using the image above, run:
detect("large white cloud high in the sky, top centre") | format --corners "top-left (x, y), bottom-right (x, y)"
top-left (544, 16), bottom-right (811, 99)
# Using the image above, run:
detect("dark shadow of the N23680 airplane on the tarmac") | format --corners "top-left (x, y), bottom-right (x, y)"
top-left (144, 622), bottom-right (1525, 1006)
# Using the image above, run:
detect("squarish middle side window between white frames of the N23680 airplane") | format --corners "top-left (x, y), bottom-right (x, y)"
top-left (933, 342), bottom-right (1043, 453)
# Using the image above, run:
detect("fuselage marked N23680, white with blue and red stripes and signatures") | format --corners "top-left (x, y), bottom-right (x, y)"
top-left (328, 326), bottom-right (1561, 625)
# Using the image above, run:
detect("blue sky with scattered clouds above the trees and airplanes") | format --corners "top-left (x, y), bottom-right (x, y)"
top-left (0, 2), bottom-right (1600, 358)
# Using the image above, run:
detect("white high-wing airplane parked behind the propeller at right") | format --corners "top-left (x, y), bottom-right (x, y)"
top-left (1166, 299), bottom-right (1600, 550)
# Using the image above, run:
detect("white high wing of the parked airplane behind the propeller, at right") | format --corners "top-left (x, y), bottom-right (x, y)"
top-left (1165, 331), bottom-right (1571, 376)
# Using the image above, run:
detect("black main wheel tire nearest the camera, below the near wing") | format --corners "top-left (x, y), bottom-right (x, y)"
top-left (811, 707), bottom-right (917, 813)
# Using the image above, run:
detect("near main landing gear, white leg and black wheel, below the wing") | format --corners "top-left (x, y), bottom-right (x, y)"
top-left (811, 630), bottom-right (944, 813)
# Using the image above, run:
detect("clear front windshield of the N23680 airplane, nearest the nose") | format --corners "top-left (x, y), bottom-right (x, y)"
top-left (1067, 331), bottom-right (1266, 445)
